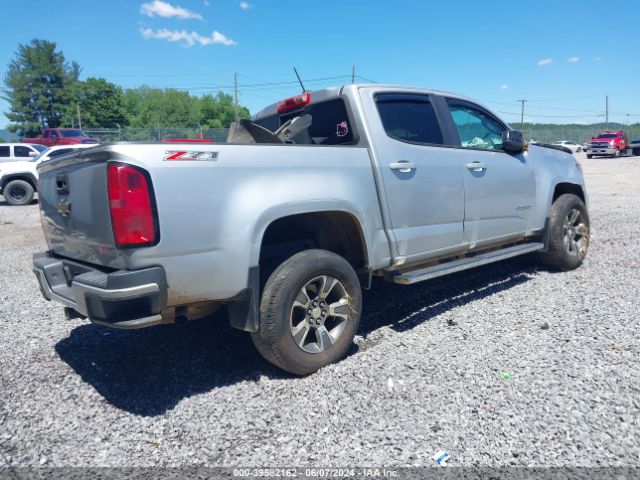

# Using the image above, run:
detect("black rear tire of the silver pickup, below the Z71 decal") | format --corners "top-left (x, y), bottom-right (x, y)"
top-left (251, 249), bottom-right (362, 375)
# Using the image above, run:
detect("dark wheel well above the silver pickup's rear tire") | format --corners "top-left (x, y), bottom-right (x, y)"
top-left (260, 211), bottom-right (367, 271)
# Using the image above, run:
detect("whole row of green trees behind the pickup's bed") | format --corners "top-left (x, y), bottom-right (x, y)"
top-left (2, 39), bottom-right (250, 137)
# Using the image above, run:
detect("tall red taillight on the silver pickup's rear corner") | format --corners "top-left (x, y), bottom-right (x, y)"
top-left (107, 163), bottom-right (158, 247)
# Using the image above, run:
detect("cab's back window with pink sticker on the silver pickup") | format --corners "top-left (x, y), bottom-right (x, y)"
top-left (255, 98), bottom-right (354, 145)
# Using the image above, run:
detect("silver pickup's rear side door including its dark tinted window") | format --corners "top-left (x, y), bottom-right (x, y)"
top-left (361, 89), bottom-right (464, 260)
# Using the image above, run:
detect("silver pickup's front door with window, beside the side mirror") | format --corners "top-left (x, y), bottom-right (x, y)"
top-left (447, 98), bottom-right (535, 248)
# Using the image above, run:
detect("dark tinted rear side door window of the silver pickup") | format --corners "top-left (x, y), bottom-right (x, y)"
top-left (376, 93), bottom-right (443, 145)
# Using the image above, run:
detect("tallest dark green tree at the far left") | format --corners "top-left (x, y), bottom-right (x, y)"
top-left (3, 39), bottom-right (80, 136)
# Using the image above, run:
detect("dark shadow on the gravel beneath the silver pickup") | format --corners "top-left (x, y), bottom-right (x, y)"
top-left (55, 256), bottom-right (535, 416)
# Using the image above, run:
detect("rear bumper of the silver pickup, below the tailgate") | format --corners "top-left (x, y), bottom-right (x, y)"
top-left (33, 253), bottom-right (167, 328)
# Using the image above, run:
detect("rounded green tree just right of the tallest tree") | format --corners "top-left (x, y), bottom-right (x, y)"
top-left (70, 77), bottom-right (129, 128)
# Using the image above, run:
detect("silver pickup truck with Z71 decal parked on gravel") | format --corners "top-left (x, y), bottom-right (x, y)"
top-left (33, 85), bottom-right (589, 375)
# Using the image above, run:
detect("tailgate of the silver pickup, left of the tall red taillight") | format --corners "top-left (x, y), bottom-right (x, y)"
top-left (38, 148), bottom-right (126, 268)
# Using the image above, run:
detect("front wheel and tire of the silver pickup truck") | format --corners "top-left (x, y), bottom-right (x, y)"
top-left (540, 194), bottom-right (590, 270)
